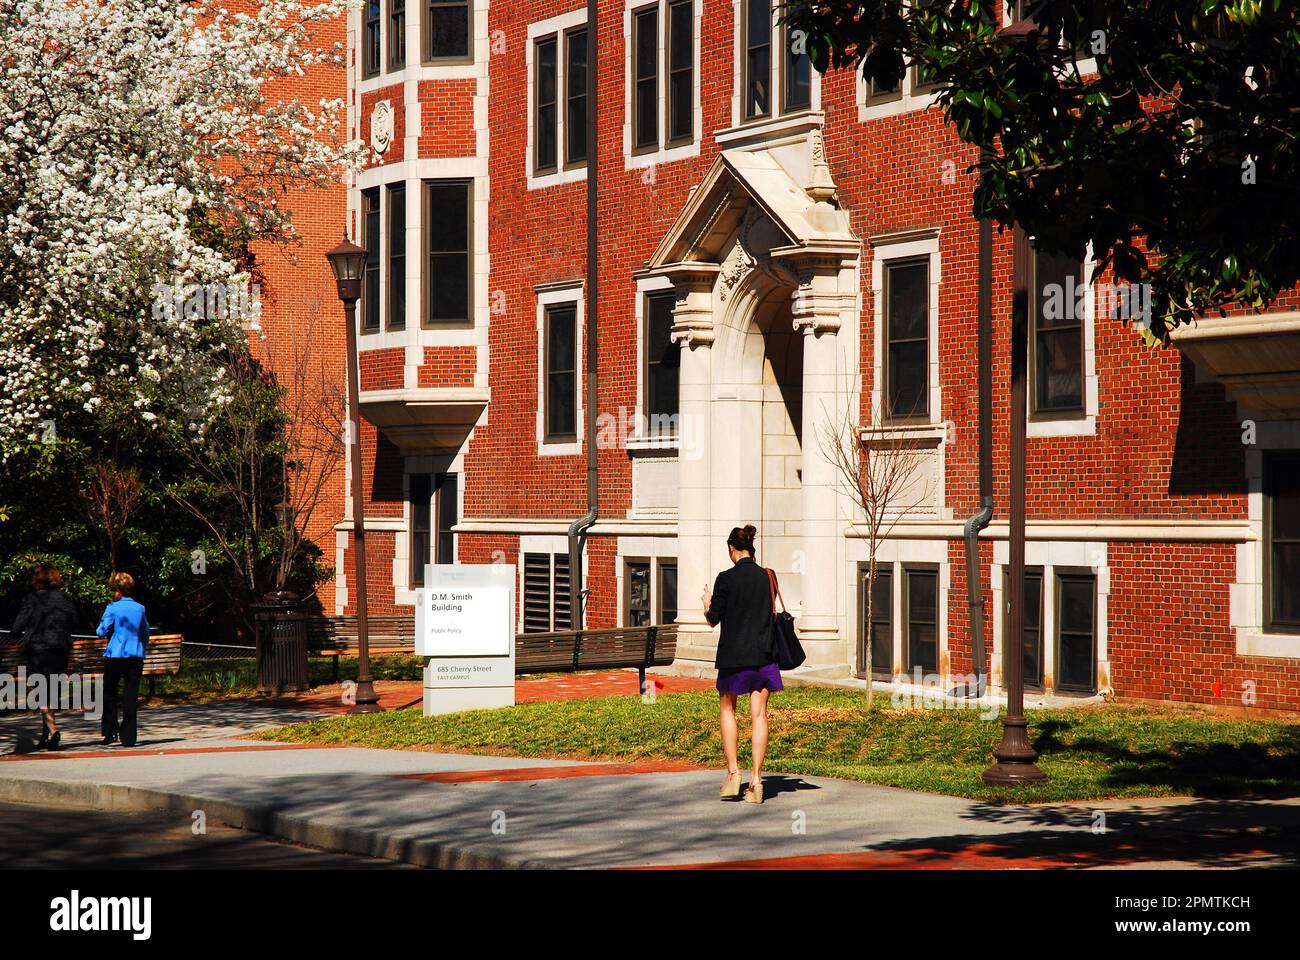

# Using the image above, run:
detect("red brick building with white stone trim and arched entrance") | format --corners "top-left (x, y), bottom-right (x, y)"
top-left (334, 0), bottom-right (1300, 709)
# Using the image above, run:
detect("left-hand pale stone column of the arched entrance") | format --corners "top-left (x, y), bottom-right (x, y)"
top-left (664, 264), bottom-right (718, 667)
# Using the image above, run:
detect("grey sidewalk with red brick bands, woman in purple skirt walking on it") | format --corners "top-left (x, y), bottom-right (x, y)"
top-left (0, 674), bottom-right (1300, 869)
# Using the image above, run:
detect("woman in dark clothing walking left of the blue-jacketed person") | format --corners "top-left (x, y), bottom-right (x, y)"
top-left (12, 563), bottom-right (77, 751)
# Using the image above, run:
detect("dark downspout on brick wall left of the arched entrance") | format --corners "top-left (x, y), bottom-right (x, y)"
top-left (568, 0), bottom-right (601, 630)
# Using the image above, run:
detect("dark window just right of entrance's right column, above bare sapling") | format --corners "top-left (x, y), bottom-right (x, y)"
top-left (884, 258), bottom-right (930, 420)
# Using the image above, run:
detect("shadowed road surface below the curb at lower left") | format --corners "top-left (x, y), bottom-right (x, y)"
top-left (0, 803), bottom-right (416, 870)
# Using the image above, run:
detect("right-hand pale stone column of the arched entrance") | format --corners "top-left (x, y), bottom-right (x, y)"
top-left (792, 255), bottom-right (855, 667)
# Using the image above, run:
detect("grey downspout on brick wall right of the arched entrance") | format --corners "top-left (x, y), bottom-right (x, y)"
top-left (954, 147), bottom-right (993, 697)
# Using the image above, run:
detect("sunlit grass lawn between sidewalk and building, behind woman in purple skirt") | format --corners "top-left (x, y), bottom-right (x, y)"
top-left (250, 687), bottom-right (1300, 803)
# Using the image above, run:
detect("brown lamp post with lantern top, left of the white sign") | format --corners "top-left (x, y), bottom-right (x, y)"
top-left (325, 235), bottom-right (384, 713)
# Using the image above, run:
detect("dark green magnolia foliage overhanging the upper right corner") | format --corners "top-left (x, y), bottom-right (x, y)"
top-left (783, 0), bottom-right (1300, 343)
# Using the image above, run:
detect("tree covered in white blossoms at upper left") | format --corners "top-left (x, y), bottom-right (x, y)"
top-left (0, 0), bottom-right (364, 460)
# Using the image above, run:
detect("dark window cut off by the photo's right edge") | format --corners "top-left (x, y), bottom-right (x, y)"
top-left (1264, 453), bottom-right (1300, 632)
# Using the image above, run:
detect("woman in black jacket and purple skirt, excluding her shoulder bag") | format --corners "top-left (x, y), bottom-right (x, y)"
top-left (701, 526), bottom-right (783, 804)
